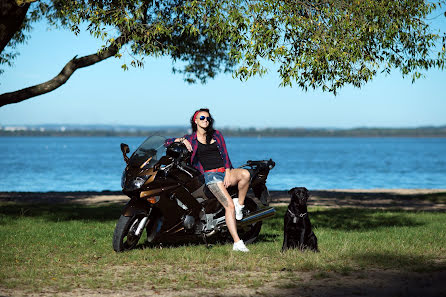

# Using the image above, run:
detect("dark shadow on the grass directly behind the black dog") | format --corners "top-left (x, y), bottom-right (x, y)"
top-left (268, 207), bottom-right (423, 231)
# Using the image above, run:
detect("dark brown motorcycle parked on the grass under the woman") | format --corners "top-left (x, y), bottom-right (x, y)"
top-left (113, 136), bottom-right (276, 252)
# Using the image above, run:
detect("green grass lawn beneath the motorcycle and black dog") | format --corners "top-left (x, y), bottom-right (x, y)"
top-left (0, 203), bottom-right (446, 292)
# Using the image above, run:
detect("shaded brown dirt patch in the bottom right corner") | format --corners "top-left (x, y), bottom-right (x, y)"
top-left (261, 269), bottom-right (446, 297)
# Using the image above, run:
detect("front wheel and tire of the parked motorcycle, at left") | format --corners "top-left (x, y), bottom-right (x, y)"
top-left (113, 215), bottom-right (144, 252)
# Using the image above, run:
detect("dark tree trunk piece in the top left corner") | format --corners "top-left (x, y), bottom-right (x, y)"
top-left (0, 0), bottom-right (30, 53)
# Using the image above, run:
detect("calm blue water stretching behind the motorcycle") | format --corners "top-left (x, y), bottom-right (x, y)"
top-left (0, 137), bottom-right (446, 191)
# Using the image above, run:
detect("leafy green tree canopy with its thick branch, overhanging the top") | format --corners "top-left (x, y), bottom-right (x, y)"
top-left (0, 0), bottom-right (445, 106)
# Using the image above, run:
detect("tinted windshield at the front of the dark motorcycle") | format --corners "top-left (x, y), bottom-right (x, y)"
top-left (129, 136), bottom-right (166, 168)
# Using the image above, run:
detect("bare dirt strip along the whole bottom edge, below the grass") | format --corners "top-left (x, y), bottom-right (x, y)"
top-left (0, 269), bottom-right (446, 297)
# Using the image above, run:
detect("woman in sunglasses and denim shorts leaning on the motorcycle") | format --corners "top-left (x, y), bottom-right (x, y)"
top-left (166, 108), bottom-right (250, 252)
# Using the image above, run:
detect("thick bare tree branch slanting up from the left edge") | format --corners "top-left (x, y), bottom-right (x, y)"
top-left (0, 36), bottom-right (127, 107)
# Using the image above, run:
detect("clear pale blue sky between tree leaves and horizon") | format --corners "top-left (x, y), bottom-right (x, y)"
top-left (0, 18), bottom-right (446, 128)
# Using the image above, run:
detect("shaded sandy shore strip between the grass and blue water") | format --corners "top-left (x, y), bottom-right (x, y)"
top-left (0, 189), bottom-right (446, 211)
